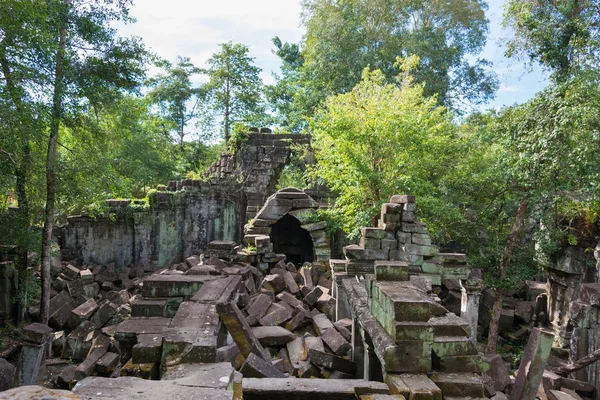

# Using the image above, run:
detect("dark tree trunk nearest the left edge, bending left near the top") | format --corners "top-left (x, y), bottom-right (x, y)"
top-left (0, 37), bottom-right (31, 324)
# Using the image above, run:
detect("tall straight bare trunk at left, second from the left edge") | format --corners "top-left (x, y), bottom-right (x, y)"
top-left (40, 26), bottom-right (67, 324)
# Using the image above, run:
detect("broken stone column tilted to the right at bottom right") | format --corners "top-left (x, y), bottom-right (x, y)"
top-left (510, 328), bottom-right (554, 400)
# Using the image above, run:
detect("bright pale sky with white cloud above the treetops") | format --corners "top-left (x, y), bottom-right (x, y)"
top-left (118, 0), bottom-right (547, 109)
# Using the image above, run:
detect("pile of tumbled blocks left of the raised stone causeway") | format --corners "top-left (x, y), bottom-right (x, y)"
top-left (48, 263), bottom-right (161, 387)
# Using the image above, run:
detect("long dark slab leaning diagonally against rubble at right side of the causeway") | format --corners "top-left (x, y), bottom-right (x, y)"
top-left (217, 302), bottom-right (271, 362)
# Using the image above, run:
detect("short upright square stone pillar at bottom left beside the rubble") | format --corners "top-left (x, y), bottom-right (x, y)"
top-left (19, 322), bottom-right (52, 386)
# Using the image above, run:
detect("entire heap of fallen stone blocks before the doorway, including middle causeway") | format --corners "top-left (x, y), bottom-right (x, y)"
top-left (43, 241), bottom-right (356, 387)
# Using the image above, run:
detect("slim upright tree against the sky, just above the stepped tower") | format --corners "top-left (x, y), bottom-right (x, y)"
top-left (203, 42), bottom-right (265, 141)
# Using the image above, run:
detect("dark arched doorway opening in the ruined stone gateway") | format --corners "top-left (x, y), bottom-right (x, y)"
top-left (270, 214), bottom-right (314, 265)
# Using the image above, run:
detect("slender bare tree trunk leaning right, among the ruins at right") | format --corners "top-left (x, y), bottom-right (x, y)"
top-left (487, 199), bottom-right (527, 353)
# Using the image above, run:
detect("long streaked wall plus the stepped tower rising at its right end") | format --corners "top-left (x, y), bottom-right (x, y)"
top-left (56, 132), bottom-right (310, 267)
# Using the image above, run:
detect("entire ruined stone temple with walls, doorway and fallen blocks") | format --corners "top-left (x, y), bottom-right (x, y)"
top-left (0, 133), bottom-right (600, 400)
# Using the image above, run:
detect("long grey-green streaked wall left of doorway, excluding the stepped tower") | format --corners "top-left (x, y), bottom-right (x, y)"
top-left (58, 185), bottom-right (245, 267)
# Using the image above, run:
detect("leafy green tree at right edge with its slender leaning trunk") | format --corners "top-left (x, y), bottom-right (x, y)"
top-left (480, 79), bottom-right (600, 351)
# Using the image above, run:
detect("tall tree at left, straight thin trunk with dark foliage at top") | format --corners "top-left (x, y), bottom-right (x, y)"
top-left (40, 0), bottom-right (146, 323)
